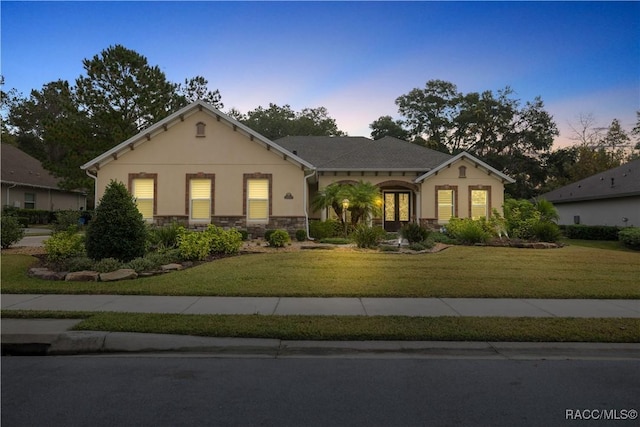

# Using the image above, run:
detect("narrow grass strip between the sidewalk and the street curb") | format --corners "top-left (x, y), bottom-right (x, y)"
top-left (2, 310), bottom-right (640, 342)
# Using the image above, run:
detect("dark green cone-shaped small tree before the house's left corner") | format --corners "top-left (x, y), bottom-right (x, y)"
top-left (86, 181), bottom-right (147, 262)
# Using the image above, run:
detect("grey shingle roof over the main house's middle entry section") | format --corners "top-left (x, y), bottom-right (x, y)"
top-left (274, 136), bottom-right (452, 172)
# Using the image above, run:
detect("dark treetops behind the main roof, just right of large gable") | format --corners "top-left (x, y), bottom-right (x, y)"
top-left (230, 104), bottom-right (344, 139)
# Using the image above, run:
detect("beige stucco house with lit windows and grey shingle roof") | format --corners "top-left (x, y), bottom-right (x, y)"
top-left (82, 101), bottom-right (513, 235)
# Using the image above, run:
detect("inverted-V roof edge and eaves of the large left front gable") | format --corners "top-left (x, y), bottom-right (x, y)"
top-left (80, 100), bottom-right (313, 171)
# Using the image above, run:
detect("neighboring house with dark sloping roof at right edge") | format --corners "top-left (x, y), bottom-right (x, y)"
top-left (540, 159), bottom-right (640, 227)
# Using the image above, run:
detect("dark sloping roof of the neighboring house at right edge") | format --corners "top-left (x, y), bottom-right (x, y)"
top-left (540, 159), bottom-right (640, 203)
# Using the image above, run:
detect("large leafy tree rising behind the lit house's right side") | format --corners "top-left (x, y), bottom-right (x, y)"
top-left (371, 80), bottom-right (558, 198)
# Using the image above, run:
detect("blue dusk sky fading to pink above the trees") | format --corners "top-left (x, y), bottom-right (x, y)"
top-left (0, 0), bottom-right (640, 145)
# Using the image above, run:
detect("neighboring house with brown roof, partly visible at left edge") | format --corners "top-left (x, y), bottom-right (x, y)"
top-left (1, 144), bottom-right (87, 211)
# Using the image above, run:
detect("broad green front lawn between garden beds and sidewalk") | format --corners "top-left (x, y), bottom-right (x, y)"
top-left (2, 245), bottom-right (640, 298)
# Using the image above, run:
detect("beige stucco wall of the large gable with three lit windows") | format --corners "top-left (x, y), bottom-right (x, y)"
top-left (97, 112), bottom-right (305, 221)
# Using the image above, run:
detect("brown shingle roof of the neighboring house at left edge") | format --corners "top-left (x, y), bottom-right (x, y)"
top-left (1, 144), bottom-right (64, 189)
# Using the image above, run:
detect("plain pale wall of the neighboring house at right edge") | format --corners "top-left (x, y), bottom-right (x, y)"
top-left (554, 196), bottom-right (640, 227)
